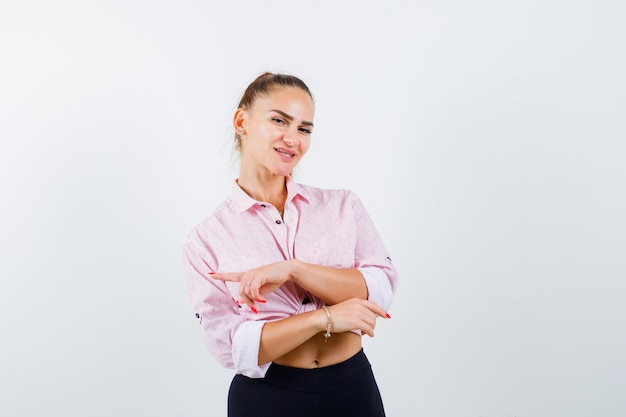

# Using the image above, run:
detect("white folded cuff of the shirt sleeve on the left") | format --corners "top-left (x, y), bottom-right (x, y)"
top-left (233, 321), bottom-right (271, 378)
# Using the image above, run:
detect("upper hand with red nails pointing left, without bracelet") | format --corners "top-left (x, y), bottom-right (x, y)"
top-left (210, 261), bottom-right (292, 312)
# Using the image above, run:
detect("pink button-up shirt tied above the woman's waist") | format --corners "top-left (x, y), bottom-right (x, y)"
top-left (183, 178), bottom-right (398, 378)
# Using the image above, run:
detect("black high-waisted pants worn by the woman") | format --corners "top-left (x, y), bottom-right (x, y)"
top-left (228, 350), bottom-right (385, 417)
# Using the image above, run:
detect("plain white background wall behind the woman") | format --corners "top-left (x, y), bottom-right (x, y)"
top-left (0, 0), bottom-right (626, 417)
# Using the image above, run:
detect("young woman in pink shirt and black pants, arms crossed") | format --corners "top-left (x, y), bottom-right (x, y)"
top-left (183, 73), bottom-right (398, 417)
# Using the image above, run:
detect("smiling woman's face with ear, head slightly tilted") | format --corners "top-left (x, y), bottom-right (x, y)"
top-left (234, 87), bottom-right (315, 176)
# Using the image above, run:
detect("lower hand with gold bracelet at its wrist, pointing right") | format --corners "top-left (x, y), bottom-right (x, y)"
top-left (320, 298), bottom-right (391, 337)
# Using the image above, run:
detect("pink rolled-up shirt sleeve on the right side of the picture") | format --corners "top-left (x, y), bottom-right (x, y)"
top-left (352, 194), bottom-right (398, 310)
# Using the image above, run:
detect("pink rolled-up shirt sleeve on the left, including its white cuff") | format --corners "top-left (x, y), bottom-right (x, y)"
top-left (183, 238), bottom-right (269, 378)
